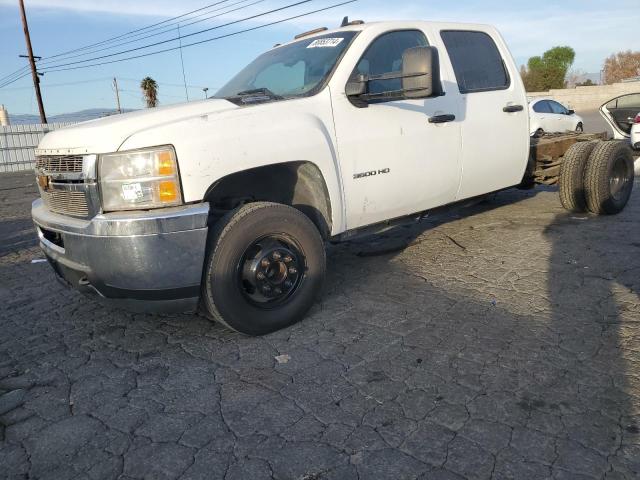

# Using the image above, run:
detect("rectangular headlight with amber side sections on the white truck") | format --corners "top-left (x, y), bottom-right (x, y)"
top-left (98, 147), bottom-right (182, 211)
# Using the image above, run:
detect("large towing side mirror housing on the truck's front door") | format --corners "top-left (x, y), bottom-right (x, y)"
top-left (402, 47), bottom-right (441, 98)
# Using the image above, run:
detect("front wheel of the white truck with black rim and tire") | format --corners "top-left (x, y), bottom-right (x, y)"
top-left (202, 202), bottom-right (326, 335)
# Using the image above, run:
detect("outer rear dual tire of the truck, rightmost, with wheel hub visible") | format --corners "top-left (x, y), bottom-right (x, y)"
top-left (584, 141), bottom-right (634, 215)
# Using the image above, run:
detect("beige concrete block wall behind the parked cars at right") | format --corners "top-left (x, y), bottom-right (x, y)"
top-left (527, 81), bottom-right (640, 111)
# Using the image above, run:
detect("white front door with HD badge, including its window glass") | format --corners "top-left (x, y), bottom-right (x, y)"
top-left (332, 30), bottom-right (462, 229)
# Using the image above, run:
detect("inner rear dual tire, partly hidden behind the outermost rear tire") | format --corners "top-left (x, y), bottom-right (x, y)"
top-left (558, 142), bottom-right (598, 212)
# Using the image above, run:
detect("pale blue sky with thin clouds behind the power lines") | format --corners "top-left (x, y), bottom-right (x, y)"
top-left (0, 0), bottom-right (640, 115)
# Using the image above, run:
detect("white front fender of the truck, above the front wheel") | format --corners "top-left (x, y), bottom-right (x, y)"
top-left (120, 88), bottom-right (345, 235)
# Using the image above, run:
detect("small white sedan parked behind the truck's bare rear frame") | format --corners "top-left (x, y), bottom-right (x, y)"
top-left (529, 98), bottom-right (584, 136)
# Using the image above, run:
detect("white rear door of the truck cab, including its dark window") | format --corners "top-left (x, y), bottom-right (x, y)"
top-left (440, 30), bottom-right (529, 199)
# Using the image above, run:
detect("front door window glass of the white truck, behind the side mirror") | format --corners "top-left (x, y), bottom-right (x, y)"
top-left (352, 30), bottom-right (428, 93)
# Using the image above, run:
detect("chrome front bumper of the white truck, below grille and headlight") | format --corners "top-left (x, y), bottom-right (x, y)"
top-left (31, 199), bottom-right (209, 312)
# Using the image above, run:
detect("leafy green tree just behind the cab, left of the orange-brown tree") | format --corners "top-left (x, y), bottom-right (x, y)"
top-left (520, 47), bottom-right (576, 92)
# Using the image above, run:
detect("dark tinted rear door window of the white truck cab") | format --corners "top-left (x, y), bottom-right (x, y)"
top-left (440, 30), bottom-right (511, 94)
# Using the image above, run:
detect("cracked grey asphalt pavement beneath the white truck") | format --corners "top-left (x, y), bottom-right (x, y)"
top-left (0, 173), bottom-right (640, 480)
